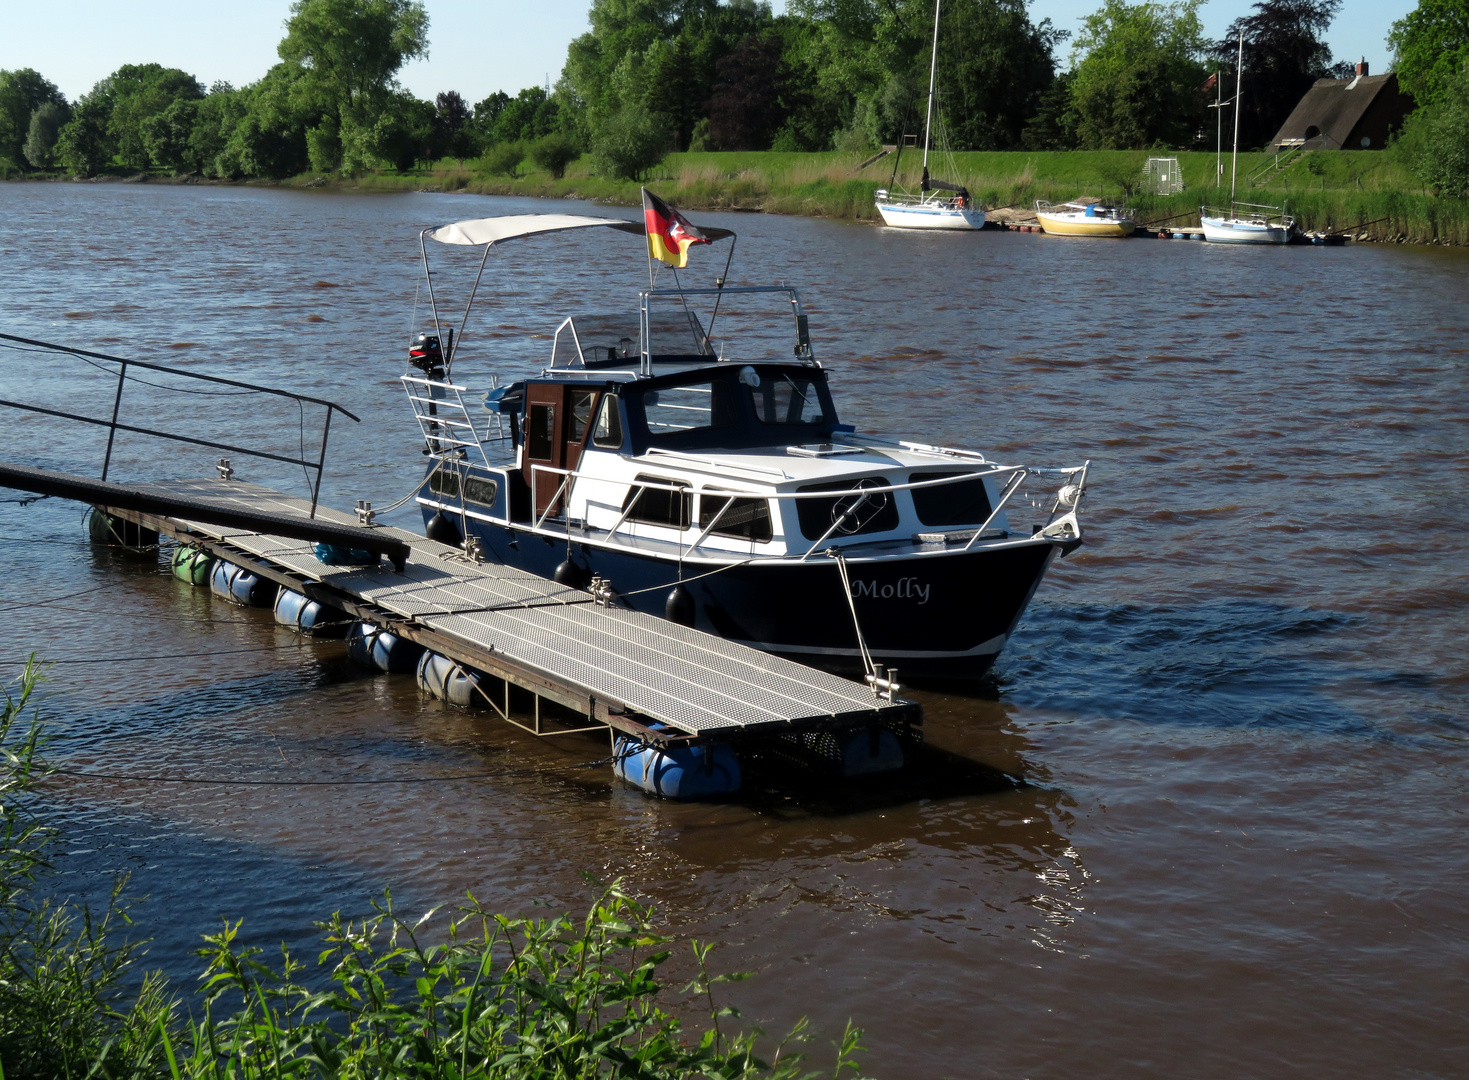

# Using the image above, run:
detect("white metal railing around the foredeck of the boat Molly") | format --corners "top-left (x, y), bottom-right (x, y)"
top-left (517, 451), bottom-right (1091, 563)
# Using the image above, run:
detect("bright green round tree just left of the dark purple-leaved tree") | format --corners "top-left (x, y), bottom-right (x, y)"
top-left (1071, 0), bottom-right (1206, 150)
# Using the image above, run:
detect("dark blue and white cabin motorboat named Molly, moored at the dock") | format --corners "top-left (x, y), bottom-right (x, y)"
top-left (403, 215), bottom-right (1089, 680)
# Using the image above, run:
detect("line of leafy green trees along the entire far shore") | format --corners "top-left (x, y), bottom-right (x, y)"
top-left (0, 0), bottom-right (1469, 193)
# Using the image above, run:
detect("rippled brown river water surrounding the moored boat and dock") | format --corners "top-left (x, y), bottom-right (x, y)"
top-left (0, 184), bottom-right (1469, 1077)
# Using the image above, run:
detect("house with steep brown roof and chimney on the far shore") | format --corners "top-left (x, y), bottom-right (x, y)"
top-left (1269, 63), bottom-right (1413, 150)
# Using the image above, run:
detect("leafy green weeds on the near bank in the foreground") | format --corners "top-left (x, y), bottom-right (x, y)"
top-left (0, 660), bottom-right (861, 1080)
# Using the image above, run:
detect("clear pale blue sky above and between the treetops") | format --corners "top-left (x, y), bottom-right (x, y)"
top-left (0, 0), bottom-right (1416, 103)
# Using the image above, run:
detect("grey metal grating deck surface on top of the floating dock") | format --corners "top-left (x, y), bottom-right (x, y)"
top-left (114, 479), bottom-right (918, 738)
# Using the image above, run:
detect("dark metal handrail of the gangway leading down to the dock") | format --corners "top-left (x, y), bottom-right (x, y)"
top-left (0, 334), bottom-right (358, 517)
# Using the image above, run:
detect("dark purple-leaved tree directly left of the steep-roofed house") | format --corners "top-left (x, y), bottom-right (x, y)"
top-left (1210, 0), bottom-right (1341, 147)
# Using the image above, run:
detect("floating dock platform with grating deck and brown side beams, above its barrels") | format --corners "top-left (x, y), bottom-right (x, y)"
top-left (66, 470), bottom-right (923, 748)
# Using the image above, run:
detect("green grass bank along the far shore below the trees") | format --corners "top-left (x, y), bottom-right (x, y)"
top-left (321, 150), bottom-right (1469, 244)
